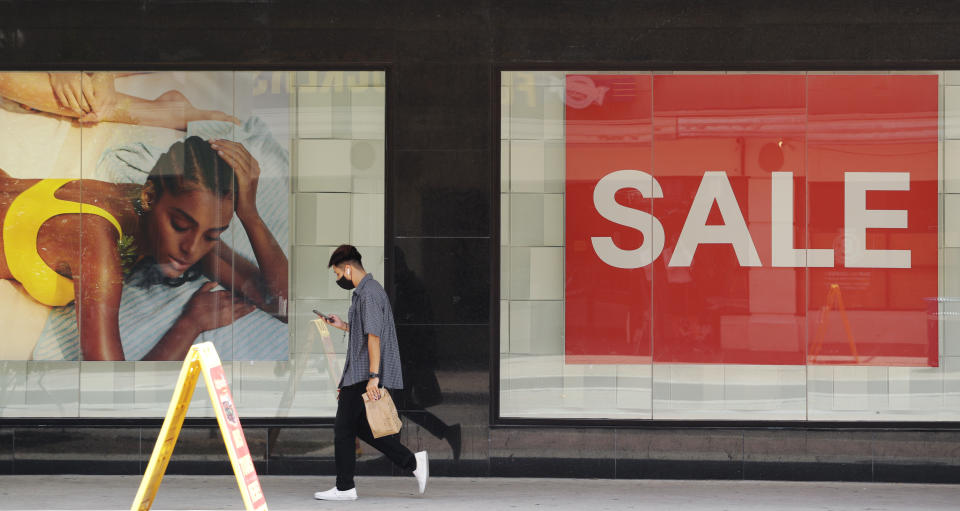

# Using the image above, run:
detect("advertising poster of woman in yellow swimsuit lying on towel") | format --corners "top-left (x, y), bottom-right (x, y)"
top-left (0, 72), bottom-right (291, 361)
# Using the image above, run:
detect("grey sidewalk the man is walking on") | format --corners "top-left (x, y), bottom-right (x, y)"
top-left (0, 475), bottom-right (960, 511)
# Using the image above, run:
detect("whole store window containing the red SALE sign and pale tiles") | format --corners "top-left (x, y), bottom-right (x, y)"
top-left (499, 71), bottom-right (960, 421)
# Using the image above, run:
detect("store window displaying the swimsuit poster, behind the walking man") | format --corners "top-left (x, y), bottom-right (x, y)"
top-left (0, 71), bottom-right (385, 418)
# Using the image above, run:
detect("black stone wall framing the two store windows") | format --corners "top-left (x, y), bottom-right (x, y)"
top-left (0, 0), bottom-right (960, 482)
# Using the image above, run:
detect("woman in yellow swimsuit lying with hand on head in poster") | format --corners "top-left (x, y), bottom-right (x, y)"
top-left (0, 137), bottom-right (288, 360)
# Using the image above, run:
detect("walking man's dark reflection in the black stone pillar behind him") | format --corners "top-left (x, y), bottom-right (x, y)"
top-left (393, 248), bottom-right (461, 460)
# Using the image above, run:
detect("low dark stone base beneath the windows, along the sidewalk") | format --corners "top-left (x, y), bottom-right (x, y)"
top-left (0, 426), bottom-right (960, 484)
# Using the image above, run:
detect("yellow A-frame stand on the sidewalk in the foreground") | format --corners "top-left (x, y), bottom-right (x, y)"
top-left (130, 342), bottom-right (267, 511)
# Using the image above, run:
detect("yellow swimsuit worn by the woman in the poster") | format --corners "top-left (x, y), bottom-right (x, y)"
top-left (3, 179), bottom-right (123, 306)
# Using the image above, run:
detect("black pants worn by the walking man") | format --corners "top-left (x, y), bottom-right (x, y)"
top-left (333, 381), bottom-right (417, 491)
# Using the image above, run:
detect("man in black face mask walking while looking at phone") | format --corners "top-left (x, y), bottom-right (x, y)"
top-left (313, 245), bottom-right (430, 500)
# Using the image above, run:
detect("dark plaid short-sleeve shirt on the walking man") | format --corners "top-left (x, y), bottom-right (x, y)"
top-left (339, 273), bottom-right (403, 389)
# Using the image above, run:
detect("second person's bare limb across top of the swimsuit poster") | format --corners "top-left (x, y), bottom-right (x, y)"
top-left (0, 72), bottom-right (240, 130)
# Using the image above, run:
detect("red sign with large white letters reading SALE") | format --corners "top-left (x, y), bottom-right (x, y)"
top-left (565, 74), bottom-right (939, 366)
